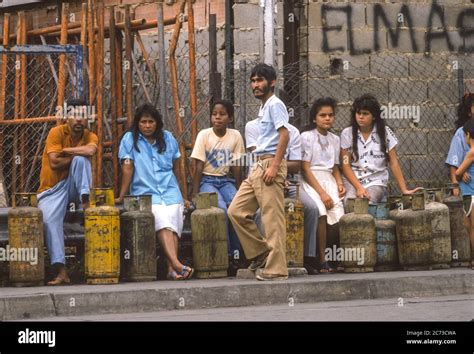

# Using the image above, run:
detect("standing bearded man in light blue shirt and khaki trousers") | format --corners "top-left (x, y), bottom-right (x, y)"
top-left (228, 64), bottom-right (289, 280)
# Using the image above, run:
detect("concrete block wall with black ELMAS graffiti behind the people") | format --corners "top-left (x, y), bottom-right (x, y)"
top-left (234, 0), bottom-right (474, 191)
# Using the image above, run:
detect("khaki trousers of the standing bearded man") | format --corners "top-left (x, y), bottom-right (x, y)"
top-left (228, 158), bottom-right (288, 276)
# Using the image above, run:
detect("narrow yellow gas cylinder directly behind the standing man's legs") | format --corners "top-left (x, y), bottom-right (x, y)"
top-left (285, 183), bottom-right (304, 267)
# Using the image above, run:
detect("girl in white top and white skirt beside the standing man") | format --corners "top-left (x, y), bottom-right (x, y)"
top-left (301, 98), bottom-right (345, 273)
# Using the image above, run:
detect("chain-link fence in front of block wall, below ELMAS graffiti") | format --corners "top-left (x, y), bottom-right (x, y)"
top-left (234, 54), bottom-right (474, 193)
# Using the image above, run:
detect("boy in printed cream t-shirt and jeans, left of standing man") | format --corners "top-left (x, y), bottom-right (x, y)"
top-left (191, 100), bottom-right (245, 276)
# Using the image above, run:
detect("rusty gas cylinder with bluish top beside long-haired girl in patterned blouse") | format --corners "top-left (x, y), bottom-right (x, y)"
top-left (369, 203), bottom-right (398, 272)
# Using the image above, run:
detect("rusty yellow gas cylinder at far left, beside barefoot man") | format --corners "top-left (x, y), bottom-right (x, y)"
top-left (5, 193), bottom-right (44, 287)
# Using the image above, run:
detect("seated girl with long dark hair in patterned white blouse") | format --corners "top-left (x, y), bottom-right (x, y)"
top-left (341, 94), bottom-right (419, 203)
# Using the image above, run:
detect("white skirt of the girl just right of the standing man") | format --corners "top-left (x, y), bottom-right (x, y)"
top-left (301, 171), bottom-right (344, 225)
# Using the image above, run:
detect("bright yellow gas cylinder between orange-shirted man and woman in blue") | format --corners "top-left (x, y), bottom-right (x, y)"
top-left (84, 188), bottom-right (120, 284)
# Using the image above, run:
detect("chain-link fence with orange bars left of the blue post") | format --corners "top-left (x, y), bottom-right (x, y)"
top-left (0, 49), bottom-right (78, 202)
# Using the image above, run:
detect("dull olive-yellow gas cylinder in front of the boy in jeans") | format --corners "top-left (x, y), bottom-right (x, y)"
top-left (191, 193), bottom-right (229, 279)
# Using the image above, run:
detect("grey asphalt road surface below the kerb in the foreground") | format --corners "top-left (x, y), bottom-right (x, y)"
top-left (25, 295), bottom-right (474, 321)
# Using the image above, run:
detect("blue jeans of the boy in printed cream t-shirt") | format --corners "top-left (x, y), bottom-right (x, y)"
top-left (199, 175), bottom-right (240, 258)
